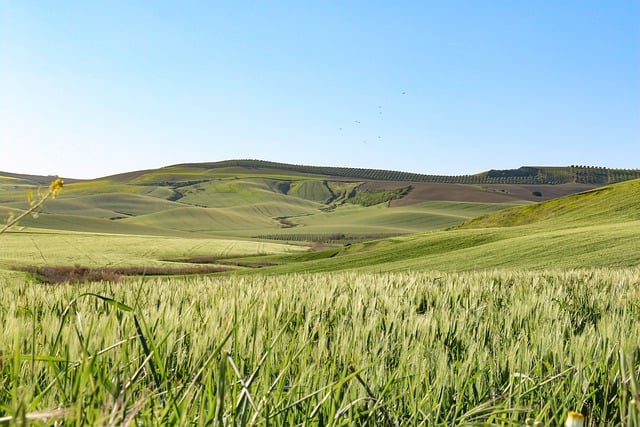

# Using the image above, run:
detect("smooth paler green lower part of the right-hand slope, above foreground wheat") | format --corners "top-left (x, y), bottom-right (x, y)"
top-left (254, 221), bottom-right (640, 272)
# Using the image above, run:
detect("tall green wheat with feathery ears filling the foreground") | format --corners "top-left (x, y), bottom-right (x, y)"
top-left (0, 269), bottom-right (640, 426)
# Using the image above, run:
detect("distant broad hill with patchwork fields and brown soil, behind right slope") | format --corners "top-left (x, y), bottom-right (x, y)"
top-left (0, 160), bottom-right (637, 242)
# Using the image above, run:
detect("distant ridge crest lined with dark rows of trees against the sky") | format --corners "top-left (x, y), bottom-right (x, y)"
top-left (174, 159), bottom-right (640, 185)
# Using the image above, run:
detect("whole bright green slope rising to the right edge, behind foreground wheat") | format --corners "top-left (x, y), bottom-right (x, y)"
top-left (249, 180), bottom-right (640, 272)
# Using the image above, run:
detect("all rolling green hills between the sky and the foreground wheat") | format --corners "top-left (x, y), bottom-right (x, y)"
top-left (0, 160), bottom-right (640, 274)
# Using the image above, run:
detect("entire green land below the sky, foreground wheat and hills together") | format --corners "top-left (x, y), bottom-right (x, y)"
top-left (0, 161), bottom-right (640, 426)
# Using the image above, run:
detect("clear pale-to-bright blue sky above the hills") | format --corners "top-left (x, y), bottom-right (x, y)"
top-left (0, 0), bottom-right (640, 178)
